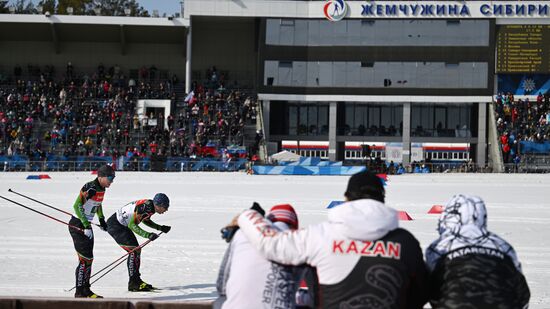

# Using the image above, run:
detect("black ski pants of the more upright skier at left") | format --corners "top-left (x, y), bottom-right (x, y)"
top-left (69, 217), bottom-right (94, 291)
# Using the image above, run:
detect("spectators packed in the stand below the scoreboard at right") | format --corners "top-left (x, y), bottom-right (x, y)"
top-left (495, 92), bottom-right (550, 164)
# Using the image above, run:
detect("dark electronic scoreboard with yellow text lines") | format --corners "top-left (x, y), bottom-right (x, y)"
top-left (496, 25), bottom-right (550, 73)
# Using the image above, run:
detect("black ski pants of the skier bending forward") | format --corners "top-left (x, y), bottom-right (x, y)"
top-left (107, 214), bottom-right (141, 283)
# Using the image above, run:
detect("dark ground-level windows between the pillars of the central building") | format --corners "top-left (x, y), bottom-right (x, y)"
top-left (270, 101), bottom-right (477, 138)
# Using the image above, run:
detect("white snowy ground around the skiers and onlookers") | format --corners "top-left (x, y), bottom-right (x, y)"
top-left (0, 172), bottom-right (550, 308)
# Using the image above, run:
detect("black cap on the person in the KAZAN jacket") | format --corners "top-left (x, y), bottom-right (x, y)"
top-left (344, 171), bottom-right (386, 203)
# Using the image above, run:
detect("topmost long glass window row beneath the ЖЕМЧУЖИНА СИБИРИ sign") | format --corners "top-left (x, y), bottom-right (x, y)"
top-left (265, 18), bottom-right (490, 46)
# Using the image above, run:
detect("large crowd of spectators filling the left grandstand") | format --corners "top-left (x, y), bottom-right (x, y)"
top-left (0, 63), bottom-right (256, 164)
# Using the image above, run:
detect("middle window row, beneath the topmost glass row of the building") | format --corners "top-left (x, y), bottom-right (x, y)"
top-left (264, 60), bottom-right (488, 89)
